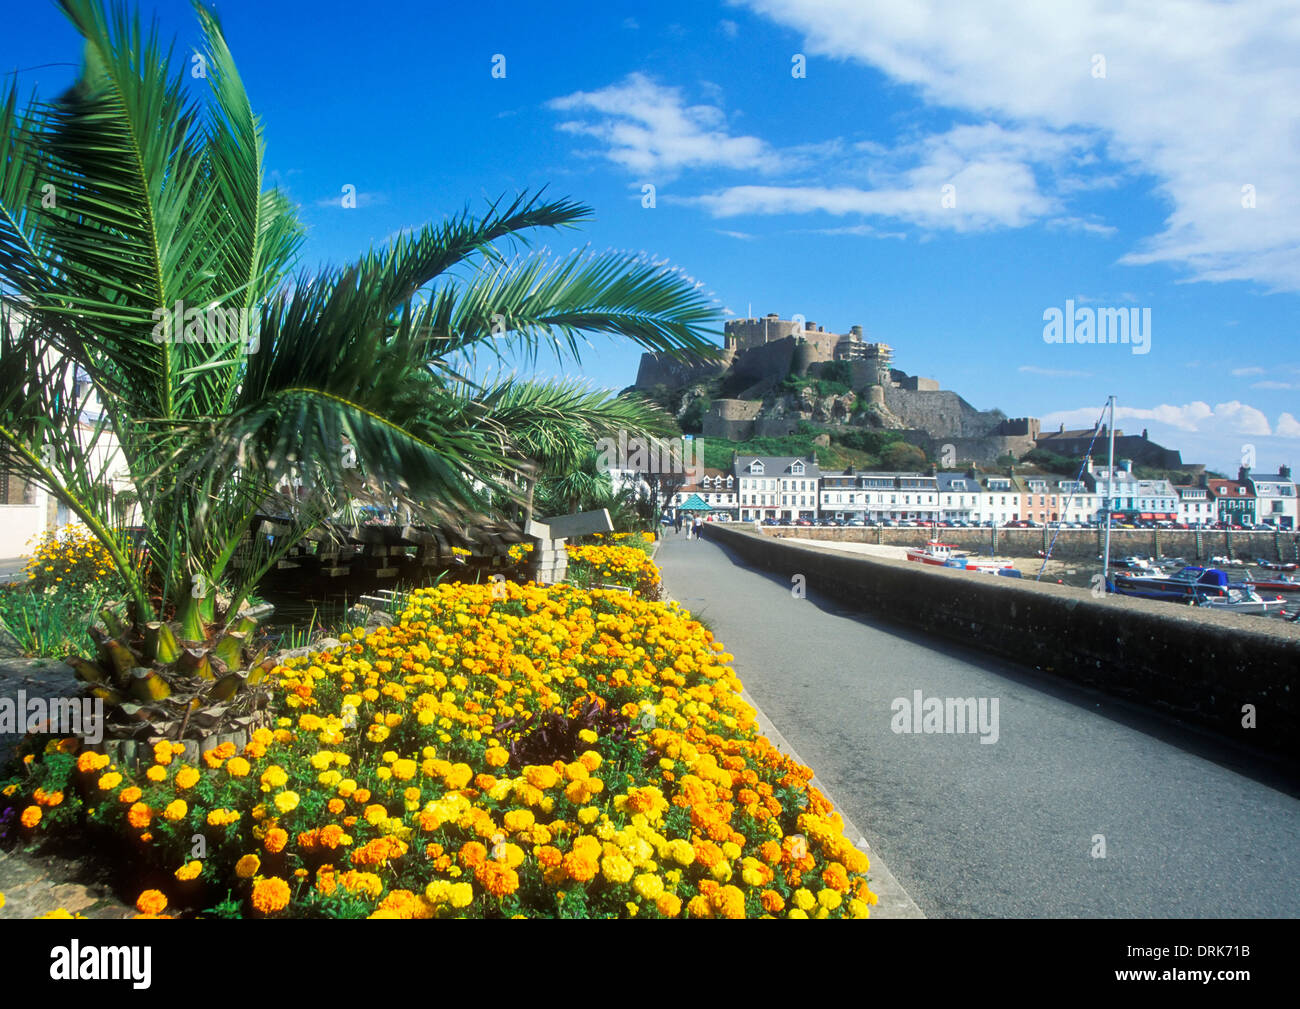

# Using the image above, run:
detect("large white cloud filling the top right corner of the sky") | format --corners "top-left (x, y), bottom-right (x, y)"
top-left (736, 0), bottom-right (1300, 291)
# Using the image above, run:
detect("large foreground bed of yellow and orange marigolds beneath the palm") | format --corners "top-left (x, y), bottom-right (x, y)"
top-left (0, 547), bottom-right (875, 918)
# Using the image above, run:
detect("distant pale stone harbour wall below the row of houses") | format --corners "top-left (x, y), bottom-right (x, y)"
top-left (759, 523), bottom-right (1300, 563)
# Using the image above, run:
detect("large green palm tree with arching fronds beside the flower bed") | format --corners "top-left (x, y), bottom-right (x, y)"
top-left (0, 0), bottom-right (718, 738)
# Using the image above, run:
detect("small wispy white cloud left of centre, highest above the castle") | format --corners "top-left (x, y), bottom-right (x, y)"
top-left (547, 73), bottom-right (768, 176)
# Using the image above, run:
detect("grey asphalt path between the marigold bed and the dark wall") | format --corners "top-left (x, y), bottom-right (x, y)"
top-left (655, 531), bottom-right (1300, 920)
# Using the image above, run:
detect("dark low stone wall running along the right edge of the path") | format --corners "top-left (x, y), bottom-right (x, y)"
top-left (705, 523), bottom-right (1300, 759)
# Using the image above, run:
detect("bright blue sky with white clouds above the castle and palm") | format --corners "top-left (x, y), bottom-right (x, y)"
top-left (0, 0), bottom-right (1300, 471)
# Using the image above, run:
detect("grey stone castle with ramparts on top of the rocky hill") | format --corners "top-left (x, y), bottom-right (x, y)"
top-left (636, 312), bottom-right (1182, 468)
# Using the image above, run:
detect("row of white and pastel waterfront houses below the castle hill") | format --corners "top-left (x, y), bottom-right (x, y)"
top-left (667, 455), bottom-right (1297, 529)
